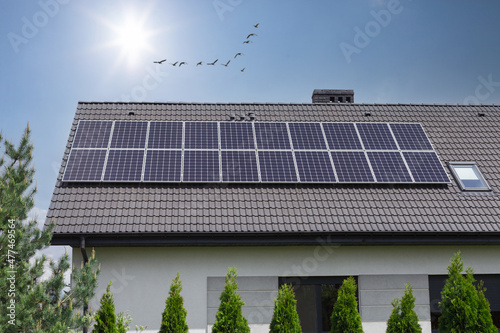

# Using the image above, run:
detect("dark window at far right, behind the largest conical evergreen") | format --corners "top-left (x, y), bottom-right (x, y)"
top-left (429, 274), bottom-right (500, 333)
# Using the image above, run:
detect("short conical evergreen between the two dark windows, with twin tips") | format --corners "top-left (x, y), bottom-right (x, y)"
top-left (386, 284), bottom-right (422, 333)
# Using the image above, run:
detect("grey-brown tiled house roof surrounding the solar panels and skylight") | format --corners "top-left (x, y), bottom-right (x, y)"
top-left (46, 102), bottom-right (500, 245)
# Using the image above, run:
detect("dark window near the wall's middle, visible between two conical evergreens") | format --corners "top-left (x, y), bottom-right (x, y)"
top-left (280, 276), bottom-right (358, 333)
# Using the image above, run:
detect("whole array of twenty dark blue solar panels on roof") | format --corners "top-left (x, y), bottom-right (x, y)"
top-left (63, 120), bottom-right (450, 184)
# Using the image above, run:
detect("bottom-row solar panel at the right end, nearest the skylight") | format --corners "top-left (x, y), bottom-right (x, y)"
top-left (403, 152), bottom-right (450, 183)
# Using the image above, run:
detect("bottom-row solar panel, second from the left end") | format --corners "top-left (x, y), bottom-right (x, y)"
top-left (104, 150), bottom-right (144, 182)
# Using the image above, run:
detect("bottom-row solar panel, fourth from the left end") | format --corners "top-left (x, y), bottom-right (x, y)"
top-left (182, 150), bottom-right (220, 182)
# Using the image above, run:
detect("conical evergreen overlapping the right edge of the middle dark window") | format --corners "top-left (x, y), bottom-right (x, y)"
top-left (330, 276), bottom-right (363, 333)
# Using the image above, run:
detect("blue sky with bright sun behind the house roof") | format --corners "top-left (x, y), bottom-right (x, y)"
top-left (0, 0), bottom-right (500, 262)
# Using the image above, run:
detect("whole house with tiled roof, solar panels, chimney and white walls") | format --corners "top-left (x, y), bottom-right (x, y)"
top-left (47, 90), bottom-right (500, 333)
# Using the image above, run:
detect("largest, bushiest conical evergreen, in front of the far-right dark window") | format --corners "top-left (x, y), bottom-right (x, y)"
top-left (439, 252), bottom-right (497, 333)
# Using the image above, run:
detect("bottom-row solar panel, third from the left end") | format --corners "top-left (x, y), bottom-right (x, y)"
top-left (144, 150), bottom-right (182, 182)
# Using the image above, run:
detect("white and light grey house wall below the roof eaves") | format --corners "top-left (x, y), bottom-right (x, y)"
top-left (73, 243), bottom-right (500, 333)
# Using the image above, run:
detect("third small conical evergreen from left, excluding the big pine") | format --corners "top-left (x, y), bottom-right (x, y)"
top-left (212, 267), bottom-right (250, 333)
